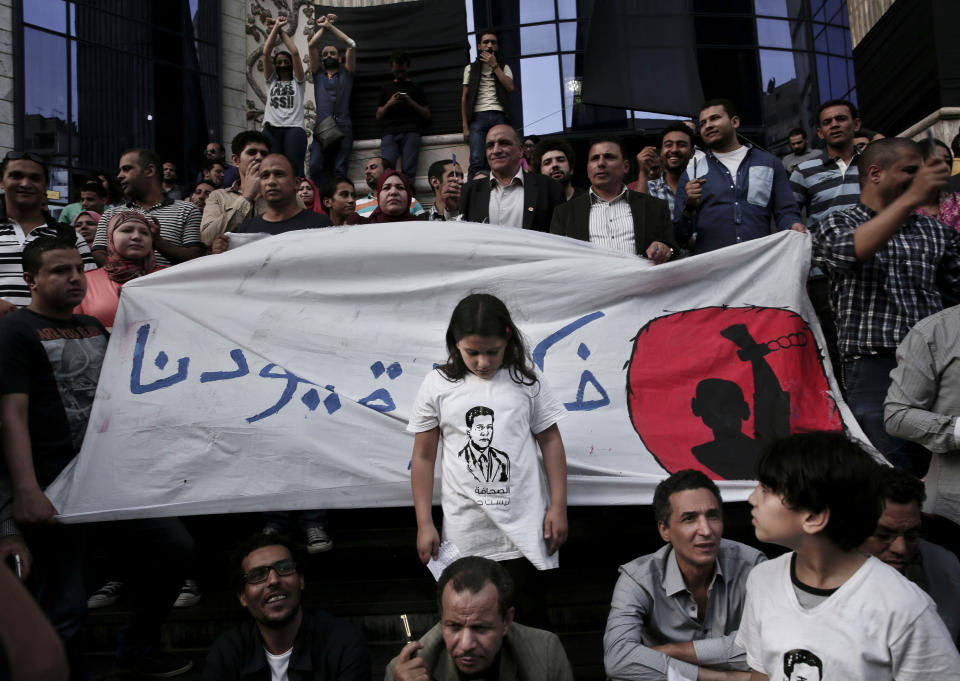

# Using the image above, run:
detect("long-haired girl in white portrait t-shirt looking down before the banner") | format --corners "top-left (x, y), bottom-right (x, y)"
top-left (407, 294), bottom-right (567, 570)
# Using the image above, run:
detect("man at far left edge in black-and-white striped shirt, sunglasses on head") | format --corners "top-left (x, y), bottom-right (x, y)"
top-left (0, 151), bottom-right (97, 317)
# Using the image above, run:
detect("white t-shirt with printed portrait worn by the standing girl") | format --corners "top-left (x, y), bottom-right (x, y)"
top-left (407, 369), bottom-right (566, 570)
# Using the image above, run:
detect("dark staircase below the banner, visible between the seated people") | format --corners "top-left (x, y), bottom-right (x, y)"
top-left (84, 503), bottom-right (772, 681)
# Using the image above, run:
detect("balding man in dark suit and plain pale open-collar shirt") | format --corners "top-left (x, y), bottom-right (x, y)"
top-left (460, 125), bottom-right (565, 232)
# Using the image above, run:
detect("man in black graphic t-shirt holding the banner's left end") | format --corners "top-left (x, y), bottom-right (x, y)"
top-left (0, 237), bottom-right (193, 678)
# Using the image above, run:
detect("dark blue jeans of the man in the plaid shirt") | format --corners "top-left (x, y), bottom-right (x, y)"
top-left (843, 354), bottom-right (930, 477)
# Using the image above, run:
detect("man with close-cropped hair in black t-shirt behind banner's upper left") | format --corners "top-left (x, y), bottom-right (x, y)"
top-left (211, 154), bottom-right (333, 253)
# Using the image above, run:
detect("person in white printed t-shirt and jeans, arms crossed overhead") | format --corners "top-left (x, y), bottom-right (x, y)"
top-left (263, 15), bottom-right (307, 175)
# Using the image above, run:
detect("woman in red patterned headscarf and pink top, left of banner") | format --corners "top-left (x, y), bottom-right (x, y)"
top-left (74, 210), bottom-right (161, 330)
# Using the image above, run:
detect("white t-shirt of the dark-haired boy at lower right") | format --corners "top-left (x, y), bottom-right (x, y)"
top-left (737, 553), bottom-right (960, 681)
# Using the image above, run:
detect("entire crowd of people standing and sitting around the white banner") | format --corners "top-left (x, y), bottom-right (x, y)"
top-left (0, 21), bottom-right (960, 681)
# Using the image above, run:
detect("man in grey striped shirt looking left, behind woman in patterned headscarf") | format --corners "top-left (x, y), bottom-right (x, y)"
top-left (93, 149), bottom-right (207, 266)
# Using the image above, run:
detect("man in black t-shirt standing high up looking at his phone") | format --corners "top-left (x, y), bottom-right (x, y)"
top-left (377, 51), bottom-right (430, 187)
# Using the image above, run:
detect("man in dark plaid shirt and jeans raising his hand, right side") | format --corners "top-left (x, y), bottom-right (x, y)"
top-left (813, 138), bottom-right (960, 476)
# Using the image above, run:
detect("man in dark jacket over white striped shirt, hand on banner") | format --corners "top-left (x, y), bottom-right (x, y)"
top-left (550, 139), bottom-right (677, 265)
